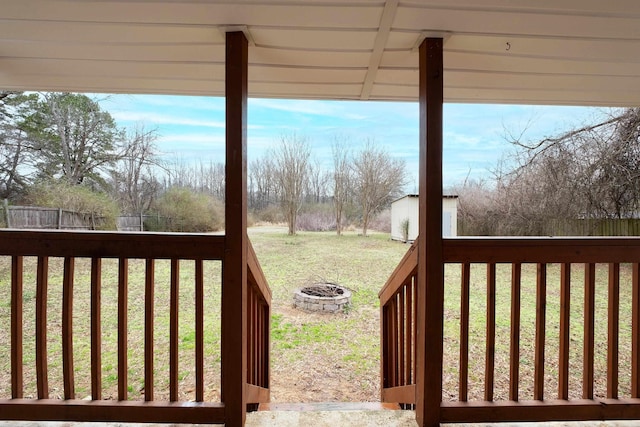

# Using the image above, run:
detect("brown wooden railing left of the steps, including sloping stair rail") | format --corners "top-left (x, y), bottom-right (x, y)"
top-left (0, 231), bottom-right (271, 423)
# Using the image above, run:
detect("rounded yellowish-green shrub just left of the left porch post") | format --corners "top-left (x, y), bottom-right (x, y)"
top-left (155, 187), bottom-right (224, 232)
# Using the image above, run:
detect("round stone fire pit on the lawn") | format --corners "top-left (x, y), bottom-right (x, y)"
top-left (293, 283), bottom-right (351, 313)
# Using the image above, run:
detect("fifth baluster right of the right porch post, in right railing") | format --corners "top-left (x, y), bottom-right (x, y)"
top-left (558, 263), bottom-right (571, 400)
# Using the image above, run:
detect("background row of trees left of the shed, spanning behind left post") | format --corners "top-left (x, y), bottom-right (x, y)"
top-left (0, 91), bottom-right (406, 234)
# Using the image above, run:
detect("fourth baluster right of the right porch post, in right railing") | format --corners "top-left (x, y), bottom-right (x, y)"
top-left (533, 264), bottom-right (547, 400)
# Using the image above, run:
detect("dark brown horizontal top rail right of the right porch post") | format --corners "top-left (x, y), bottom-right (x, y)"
top-left (443, 237), bottom-right (640, 263)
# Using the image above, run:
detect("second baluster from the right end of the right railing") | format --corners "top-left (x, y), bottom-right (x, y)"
top-left (607, 263), bottom-right (620, 399)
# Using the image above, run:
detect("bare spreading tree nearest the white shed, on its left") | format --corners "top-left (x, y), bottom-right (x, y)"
top-left (353, 140), bottom-right (407, 236)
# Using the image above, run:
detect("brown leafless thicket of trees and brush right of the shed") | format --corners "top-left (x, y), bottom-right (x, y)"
top-left (454, 108), bottom-right (640, 236)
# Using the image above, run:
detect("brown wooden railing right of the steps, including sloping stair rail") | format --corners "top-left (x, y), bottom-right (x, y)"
top-left (379, 237), bottom-right (640, 423)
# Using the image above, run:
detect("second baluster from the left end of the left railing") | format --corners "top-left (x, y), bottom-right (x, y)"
top-left (36, 256), bottom-right (49, 399)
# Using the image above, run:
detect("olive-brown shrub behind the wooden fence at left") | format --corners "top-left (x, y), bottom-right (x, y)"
top-left (26, 181), bottom-right (119, 230)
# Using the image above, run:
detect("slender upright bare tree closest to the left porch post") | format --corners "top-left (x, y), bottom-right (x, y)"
top-left (273, 134), bottom-right (311, 235)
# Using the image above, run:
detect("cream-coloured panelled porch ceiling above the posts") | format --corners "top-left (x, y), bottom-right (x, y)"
top-left (0, 0), bottom-right (640, 106)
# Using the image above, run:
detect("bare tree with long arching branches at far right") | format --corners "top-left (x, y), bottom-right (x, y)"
top-left (505, 108), bottom-right (640, 224)
